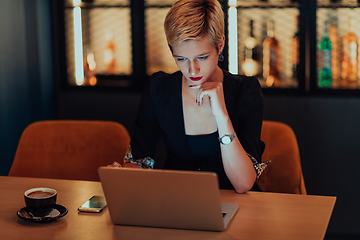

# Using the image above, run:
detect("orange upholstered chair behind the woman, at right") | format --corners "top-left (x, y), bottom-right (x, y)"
top-left (257, 121), bottom-right (306, 194)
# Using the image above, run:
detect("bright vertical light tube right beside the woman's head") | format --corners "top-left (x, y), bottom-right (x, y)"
top-left (228, 0), bottom-right (238, 74)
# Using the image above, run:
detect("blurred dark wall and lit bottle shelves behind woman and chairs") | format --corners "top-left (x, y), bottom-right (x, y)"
top-left (0, 0), bottom-right (360, 239)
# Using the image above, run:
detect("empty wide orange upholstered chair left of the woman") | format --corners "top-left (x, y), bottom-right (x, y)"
top-left (9, 120), bottom-right (130, 181)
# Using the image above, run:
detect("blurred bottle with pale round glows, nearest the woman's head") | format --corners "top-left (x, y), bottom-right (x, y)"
top-left (241, 19), bottom-right (259, 76)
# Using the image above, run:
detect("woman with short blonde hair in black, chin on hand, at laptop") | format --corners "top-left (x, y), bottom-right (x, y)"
top-left (116, 0), bottom-right (266, 193)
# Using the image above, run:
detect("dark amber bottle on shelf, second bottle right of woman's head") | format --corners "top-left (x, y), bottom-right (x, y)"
top-left (263, 20), bottom-right (281, 87)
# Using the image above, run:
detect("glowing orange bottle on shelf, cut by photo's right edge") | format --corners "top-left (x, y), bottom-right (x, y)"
top-left (341, 17), bottom-right (359, 88)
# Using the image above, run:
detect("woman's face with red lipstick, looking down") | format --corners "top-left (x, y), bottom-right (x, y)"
top-left (172, 36), bottom-right (224, 85)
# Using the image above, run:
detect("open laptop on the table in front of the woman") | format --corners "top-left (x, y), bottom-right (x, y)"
top-left (98, 167), bottom-right (238, 231)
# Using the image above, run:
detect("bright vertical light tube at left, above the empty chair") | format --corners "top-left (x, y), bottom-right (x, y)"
top-left (74, 5), bottom-right (84, 85)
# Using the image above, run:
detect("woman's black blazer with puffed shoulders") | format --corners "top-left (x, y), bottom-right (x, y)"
top-left (130, 70), bottom-right (265, 189)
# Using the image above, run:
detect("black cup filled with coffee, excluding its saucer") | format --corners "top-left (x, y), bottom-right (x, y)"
top-left (24, 188), bottom-right (57, 208)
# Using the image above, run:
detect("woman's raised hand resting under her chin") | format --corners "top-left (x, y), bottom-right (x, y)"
top-left (189, 82), bottom-right (228, 119)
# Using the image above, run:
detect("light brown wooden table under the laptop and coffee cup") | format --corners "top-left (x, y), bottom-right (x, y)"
top-left (0, 177), bottom-right (336, 240)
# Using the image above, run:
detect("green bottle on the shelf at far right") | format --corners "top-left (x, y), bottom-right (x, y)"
top-left (319, 21), bottom-right (332, 87)
